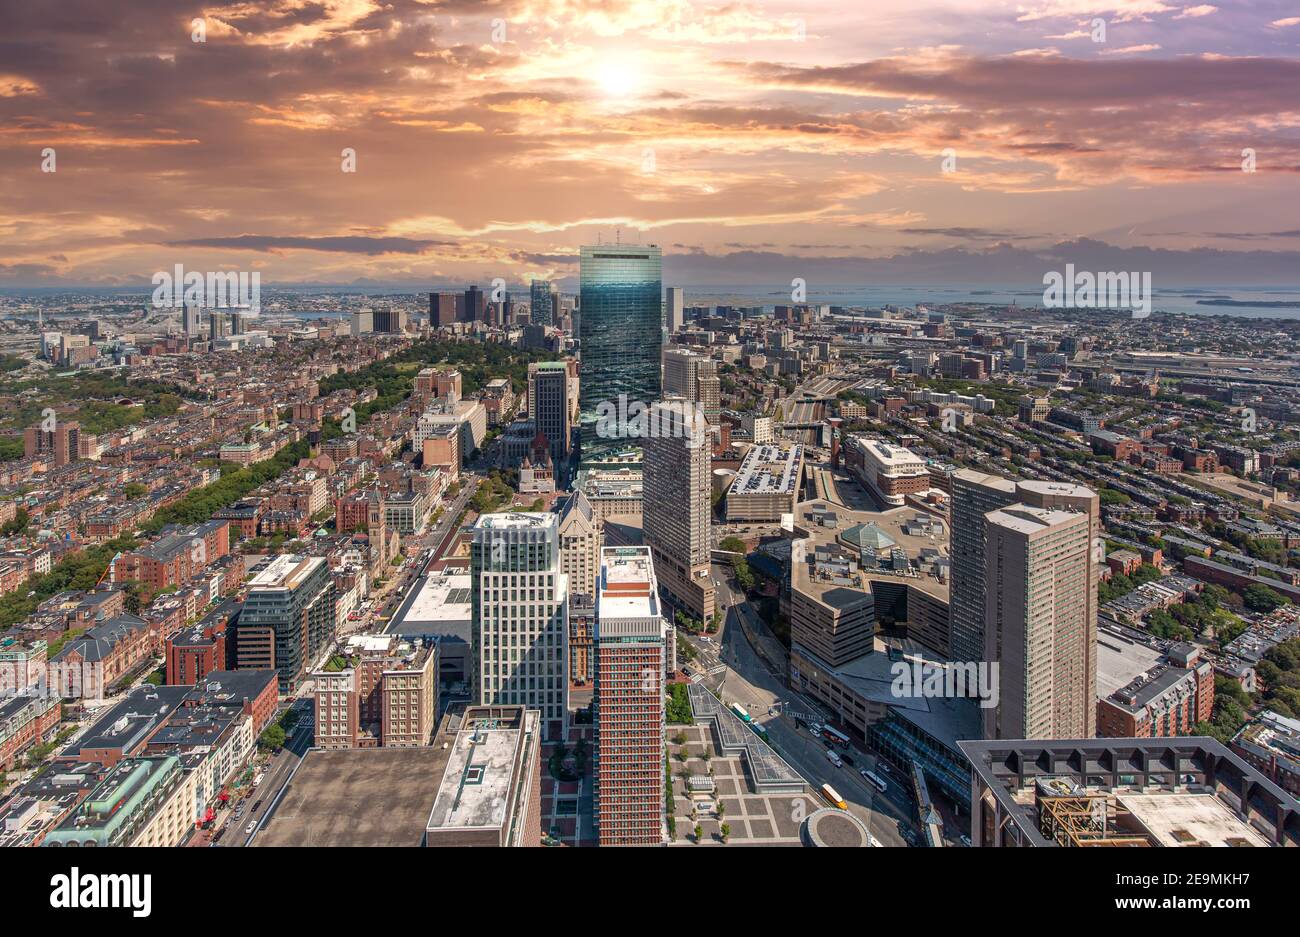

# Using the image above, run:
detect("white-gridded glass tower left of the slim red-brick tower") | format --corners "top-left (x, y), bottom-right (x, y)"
top-left (469, 512), bottom-right (568, 739)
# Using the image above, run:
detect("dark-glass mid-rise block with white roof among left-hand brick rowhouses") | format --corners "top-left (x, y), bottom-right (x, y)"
top-left (235, 554), bottom-right (335, 693)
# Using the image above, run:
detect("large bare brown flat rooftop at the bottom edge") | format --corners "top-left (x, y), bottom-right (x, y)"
top-left (251, 747), bottom-right (449, 846)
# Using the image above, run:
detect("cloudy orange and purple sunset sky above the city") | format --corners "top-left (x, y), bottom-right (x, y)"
top-left (0, 0), bottom-right (1300, 291)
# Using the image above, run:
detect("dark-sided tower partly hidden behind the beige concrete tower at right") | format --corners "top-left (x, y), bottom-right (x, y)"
top-left (948, 469), bottom-right (1019, 660)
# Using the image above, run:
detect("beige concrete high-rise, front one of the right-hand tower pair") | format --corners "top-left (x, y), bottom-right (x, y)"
top-left (984, 504), bottom-right (1097, 738)
